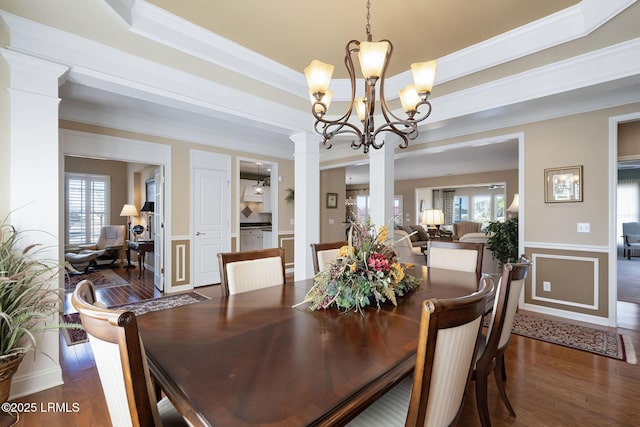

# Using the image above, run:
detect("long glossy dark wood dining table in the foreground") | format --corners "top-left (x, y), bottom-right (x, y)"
top-left (138, 266), bottom-right (478, 427)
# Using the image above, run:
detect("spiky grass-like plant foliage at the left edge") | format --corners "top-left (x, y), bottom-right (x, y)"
top-left (0, 218), bottom-right (62, 403)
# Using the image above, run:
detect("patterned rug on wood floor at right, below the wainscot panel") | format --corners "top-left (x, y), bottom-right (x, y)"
top-left (512, 313), bottom-right (637, 365)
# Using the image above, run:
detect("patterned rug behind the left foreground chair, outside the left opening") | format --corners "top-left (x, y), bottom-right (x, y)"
top-left (61, 292), bottom-right (209, 345)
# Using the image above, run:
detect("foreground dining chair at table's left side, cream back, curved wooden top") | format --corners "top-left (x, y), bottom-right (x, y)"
top-left (71, 280), bottom-right (188, 426)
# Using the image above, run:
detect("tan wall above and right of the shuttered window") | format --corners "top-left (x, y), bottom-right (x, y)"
top-left (64, 156), bottom-right (129, 231)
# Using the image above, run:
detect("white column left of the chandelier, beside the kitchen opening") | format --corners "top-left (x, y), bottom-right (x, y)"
top-left (291, 133), bottom-right (320, 280)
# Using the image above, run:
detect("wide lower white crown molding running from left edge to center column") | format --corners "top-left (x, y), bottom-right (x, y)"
top-left (0, 10), bottom-right (312, 134)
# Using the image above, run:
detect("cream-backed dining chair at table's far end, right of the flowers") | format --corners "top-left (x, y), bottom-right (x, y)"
top-left (427, 240), bottom-right (484, 277)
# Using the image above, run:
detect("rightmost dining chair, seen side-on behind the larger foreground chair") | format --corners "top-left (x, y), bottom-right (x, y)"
top-left (473, 255), bottom-right (531, 427)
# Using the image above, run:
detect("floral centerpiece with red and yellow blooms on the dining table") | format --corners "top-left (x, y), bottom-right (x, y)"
top-left (297, 220), bottom-right (420, 312)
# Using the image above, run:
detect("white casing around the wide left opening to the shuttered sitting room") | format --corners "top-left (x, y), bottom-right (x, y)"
top-left (59, 129), bottom-right (179, 293)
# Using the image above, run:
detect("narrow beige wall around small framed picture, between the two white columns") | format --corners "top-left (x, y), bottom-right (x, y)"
top-left (320, 168), bottom-right (346, 243)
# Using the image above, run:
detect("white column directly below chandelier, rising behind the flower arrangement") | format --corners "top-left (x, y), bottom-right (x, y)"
top-left (369, 141), bottom-right (396, 227)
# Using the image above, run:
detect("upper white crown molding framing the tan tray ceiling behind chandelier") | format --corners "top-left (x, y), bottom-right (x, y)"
top-left (100, 0), bottom-right (636, 101)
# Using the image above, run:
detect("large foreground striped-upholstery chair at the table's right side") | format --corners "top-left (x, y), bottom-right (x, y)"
top-left (348, 276), bottom-right (493, 427)
